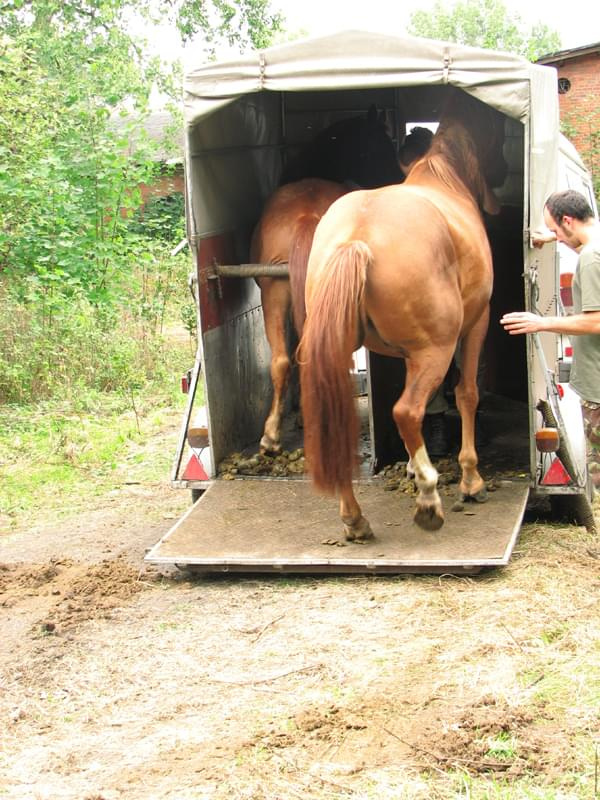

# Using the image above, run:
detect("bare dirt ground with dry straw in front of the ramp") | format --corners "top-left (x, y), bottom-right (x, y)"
top-left (0, 438), bottom-right (600, 800)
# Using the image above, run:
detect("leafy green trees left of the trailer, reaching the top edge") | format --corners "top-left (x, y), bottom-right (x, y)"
top-left (0, 0), bottom-right (281, 309)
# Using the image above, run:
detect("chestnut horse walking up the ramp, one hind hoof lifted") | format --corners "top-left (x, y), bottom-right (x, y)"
top-left (298, 89), bottom-right (507, 540)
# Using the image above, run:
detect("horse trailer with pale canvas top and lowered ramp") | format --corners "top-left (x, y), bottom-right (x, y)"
top-left (147, 31), bottom-right (595, 574)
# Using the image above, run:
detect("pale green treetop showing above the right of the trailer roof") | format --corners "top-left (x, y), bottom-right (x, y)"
top-left (408, 0), bottom-right (561, 61)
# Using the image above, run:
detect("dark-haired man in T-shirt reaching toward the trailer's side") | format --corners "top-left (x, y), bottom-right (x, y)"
top-left (500, 189), bottom-right (600, 491)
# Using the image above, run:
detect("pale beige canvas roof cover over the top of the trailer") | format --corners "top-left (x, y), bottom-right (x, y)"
top-left (184, 31), bottom-right (559, 234)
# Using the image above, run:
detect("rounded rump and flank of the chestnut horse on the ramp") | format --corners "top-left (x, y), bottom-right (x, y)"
top-left (307, 184), bottom-right (491, 352)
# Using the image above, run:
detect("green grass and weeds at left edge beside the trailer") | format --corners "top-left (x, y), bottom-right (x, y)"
top-left (0, 246), bottom-right (195, 530)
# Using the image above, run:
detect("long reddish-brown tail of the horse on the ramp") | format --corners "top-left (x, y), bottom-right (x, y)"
top-left (299, 241), bottom-right (372, 494)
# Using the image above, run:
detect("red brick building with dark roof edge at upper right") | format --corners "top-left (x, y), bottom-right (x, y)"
top-left (537, 42), bottom-right (600, 194)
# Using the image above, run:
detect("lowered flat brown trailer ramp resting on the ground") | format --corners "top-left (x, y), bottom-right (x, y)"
top-left (146, 477), bottom-right (529, 575)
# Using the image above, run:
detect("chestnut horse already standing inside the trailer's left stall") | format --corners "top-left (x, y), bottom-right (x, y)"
top-left (250, 106), bottom-right (402, 454)
